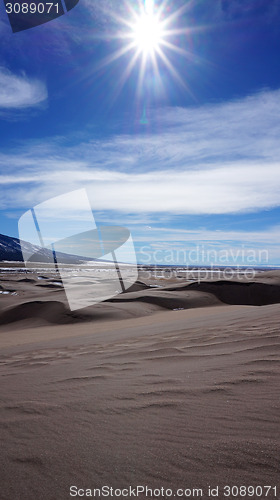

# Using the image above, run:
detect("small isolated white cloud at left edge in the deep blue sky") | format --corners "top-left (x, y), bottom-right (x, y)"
top-left (0, 67), bottom-right (48, 109)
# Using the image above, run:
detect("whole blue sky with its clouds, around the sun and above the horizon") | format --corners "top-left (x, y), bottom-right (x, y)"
top-left (0, 0), bottom-right (280, 265)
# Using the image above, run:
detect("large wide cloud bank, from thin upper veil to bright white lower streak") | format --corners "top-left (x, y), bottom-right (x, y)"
top-left (0, 86), bottom-right (280, 214)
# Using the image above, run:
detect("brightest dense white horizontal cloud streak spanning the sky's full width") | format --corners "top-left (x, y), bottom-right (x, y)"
top-left (0, 161), bottom-right (280, 214)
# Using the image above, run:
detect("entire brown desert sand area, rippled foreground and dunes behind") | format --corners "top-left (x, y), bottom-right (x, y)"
top-left (0, 269), bottom-right (280, 500)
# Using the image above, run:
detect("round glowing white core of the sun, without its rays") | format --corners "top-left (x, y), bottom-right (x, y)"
top-left (131, 11), bottom-right (164, 55)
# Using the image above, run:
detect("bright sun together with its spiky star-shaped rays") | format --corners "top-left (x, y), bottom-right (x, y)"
top-left (94, 0), bottom-right (201, 99)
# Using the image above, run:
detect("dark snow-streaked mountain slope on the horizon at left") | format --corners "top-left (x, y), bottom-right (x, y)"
top-left (0, 234), bottom-right (91, 264)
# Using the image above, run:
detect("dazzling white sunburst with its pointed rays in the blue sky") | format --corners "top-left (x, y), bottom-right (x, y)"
top-left (96, 0), bottom-right (201, 102)
